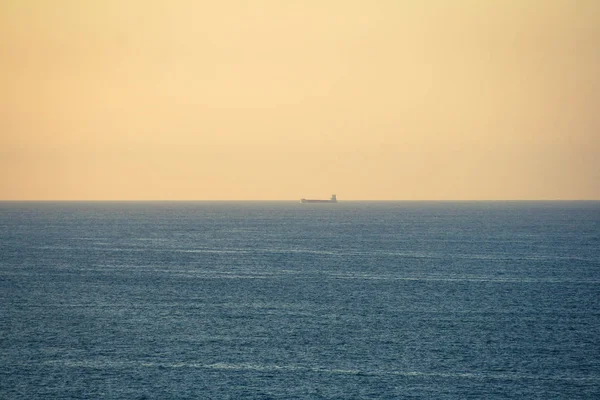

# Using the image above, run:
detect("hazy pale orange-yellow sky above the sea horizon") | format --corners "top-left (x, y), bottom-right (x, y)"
top-left (0, 0), bottom-right (600, 200)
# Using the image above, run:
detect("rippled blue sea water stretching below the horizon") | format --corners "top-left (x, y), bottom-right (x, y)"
top-left (0, 202), bottom-right (600, 399)
